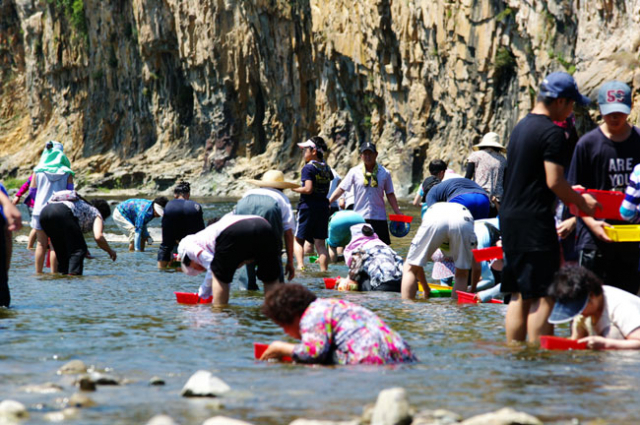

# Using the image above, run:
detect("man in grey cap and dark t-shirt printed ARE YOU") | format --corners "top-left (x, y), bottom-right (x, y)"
top-left (568, 81), bottom-right (640, 294)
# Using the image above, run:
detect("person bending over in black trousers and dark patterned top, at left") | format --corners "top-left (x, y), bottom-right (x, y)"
top-left (40, 190), bottom-right (117, 275)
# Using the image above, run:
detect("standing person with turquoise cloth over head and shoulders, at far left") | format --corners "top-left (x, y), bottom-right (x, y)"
top-left (29, 140), bottom-right (75, 273)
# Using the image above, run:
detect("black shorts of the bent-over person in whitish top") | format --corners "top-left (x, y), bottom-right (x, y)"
top-left (211, 218), bottom-right (281, 283)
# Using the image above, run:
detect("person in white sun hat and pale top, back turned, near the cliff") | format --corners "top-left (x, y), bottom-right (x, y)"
top-left (465, 132), bottom-right (507, 217)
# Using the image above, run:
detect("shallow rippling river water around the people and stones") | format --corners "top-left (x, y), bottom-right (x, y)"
top-left (0, 203), bottom-right (640, 424)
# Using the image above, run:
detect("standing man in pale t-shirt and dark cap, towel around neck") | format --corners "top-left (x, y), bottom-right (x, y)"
top-left (329, 142), bottom-right (402, 245)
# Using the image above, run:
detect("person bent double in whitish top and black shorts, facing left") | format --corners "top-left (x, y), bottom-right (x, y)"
top-left (178, 214), bottom-right (281, 305)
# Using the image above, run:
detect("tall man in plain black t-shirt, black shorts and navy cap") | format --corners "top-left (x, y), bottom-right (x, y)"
top-left (500, 72), bottom-right (598, 342)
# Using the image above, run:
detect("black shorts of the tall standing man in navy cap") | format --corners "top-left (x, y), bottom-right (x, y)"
top-left (501, 247), bottom-right (560, 300)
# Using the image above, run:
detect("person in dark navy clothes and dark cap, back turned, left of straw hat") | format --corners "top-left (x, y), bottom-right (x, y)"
top-left (158, 181), bottom-right (204, 269)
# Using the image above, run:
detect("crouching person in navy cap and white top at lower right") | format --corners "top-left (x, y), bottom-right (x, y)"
top-left (549, 267), bottom-right (640, 350)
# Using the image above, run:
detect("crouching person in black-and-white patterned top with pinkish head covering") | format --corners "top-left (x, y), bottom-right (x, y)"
top-left (338, 223), bottom-right (402, 292)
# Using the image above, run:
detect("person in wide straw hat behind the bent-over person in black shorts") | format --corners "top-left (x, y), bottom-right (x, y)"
top-left (234, 170), bottom-right (300, 290)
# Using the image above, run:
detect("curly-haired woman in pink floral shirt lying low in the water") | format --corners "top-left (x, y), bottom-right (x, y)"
top-left (260, 284), bottom-right (416, 365)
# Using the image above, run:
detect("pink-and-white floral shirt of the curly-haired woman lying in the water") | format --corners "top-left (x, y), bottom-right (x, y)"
top-left (293, 298), bottom-right (417, 365)
